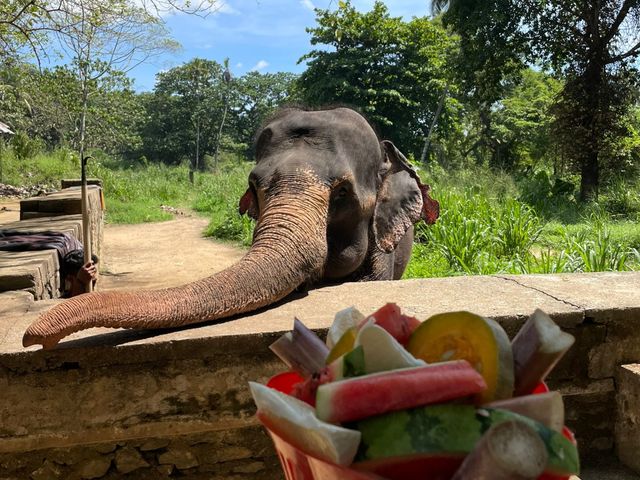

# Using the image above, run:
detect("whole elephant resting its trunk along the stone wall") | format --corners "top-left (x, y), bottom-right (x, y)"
top-left (23, 107), bottom-right (439, 348)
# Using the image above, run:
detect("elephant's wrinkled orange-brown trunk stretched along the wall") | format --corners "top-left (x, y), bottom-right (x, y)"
top-left (22, 182), bottom-right (329, 348)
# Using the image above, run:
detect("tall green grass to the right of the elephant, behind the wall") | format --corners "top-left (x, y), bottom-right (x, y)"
top-left (405, 169), bottom-right (640, 278)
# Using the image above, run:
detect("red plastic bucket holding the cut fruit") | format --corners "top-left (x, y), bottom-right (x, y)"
top-left (257, 372), bottom-right (576, 480)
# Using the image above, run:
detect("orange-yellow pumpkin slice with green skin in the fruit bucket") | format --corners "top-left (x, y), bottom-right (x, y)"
top-left (407, 312), bottom-right (513, 403)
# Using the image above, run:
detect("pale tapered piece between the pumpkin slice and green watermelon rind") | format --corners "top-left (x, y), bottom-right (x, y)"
top-left (485, 392), bottom-right (564, 432)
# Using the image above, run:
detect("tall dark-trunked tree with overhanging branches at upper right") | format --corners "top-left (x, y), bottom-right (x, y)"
top-left (433, 0), bottom-right (640, 200)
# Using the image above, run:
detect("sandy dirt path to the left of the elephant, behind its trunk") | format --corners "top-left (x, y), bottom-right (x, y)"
top-left (99, 217), bottom-right (244, 291)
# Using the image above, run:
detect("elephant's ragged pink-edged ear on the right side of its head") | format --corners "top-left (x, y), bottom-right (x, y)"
top-left (373, 140), bottom-right (439, 253)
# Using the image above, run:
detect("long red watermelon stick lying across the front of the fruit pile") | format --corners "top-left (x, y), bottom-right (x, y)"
top-left (316, 360), bottom-right (487, 423)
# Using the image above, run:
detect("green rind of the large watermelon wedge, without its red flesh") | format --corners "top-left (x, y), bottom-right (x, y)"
top-left (350, 404), bottom-right (580, 475)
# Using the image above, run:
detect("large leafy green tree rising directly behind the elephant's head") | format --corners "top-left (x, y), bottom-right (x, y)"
top-left (299, 1), bottom-right (456, 156)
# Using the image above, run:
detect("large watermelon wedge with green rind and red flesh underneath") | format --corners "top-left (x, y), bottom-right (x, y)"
top-left (349, 404), bottom-right (580, 480)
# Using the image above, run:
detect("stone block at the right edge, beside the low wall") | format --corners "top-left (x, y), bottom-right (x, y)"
top-left (615, 363), bottom-right (640, 474)
